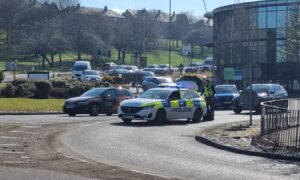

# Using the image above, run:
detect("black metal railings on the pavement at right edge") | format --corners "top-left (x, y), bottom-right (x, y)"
top-left (261, 99), bottom-right (300, 152)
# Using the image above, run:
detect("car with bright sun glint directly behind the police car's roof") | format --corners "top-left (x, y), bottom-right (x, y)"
top-left (142, 77), bottom-right (176, 91)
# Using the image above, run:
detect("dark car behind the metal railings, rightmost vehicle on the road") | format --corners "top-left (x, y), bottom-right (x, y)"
top-left (234, 84), bottom-right (288, 114)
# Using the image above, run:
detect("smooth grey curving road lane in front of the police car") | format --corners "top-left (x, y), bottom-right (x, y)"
top-left (60, 111), bottom-right (300, 179)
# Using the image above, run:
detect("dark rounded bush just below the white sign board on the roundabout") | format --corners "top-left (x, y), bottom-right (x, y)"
top-left (34, 80), bottom-right (52, 99)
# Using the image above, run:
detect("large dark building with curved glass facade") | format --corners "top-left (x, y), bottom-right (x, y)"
top-left (213, 0), bottom-right (300, 93)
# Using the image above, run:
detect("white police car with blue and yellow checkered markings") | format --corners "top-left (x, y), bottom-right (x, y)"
top-left (118, 88), bottom-right (207, 123)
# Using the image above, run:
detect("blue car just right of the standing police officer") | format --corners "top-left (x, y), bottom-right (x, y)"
top-left (215, 84), bottom-right (239, 108)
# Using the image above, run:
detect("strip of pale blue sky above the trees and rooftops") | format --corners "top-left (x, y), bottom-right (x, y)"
top-left (80, 0), bottom-right (257, 16)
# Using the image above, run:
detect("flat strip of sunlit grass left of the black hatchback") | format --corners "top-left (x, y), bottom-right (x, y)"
top-left (0, 98), bottom-right (64, 112)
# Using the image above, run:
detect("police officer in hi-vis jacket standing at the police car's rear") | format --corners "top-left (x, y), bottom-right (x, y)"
top-left (201, 79), bottom-right (216, 120)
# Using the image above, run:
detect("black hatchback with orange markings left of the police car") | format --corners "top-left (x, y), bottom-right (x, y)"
top-left (63, 88), bottom-right (134, 116)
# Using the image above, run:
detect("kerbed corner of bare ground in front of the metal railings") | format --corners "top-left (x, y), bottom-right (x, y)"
top-left (195, 120), bottom-right (300, 161)
